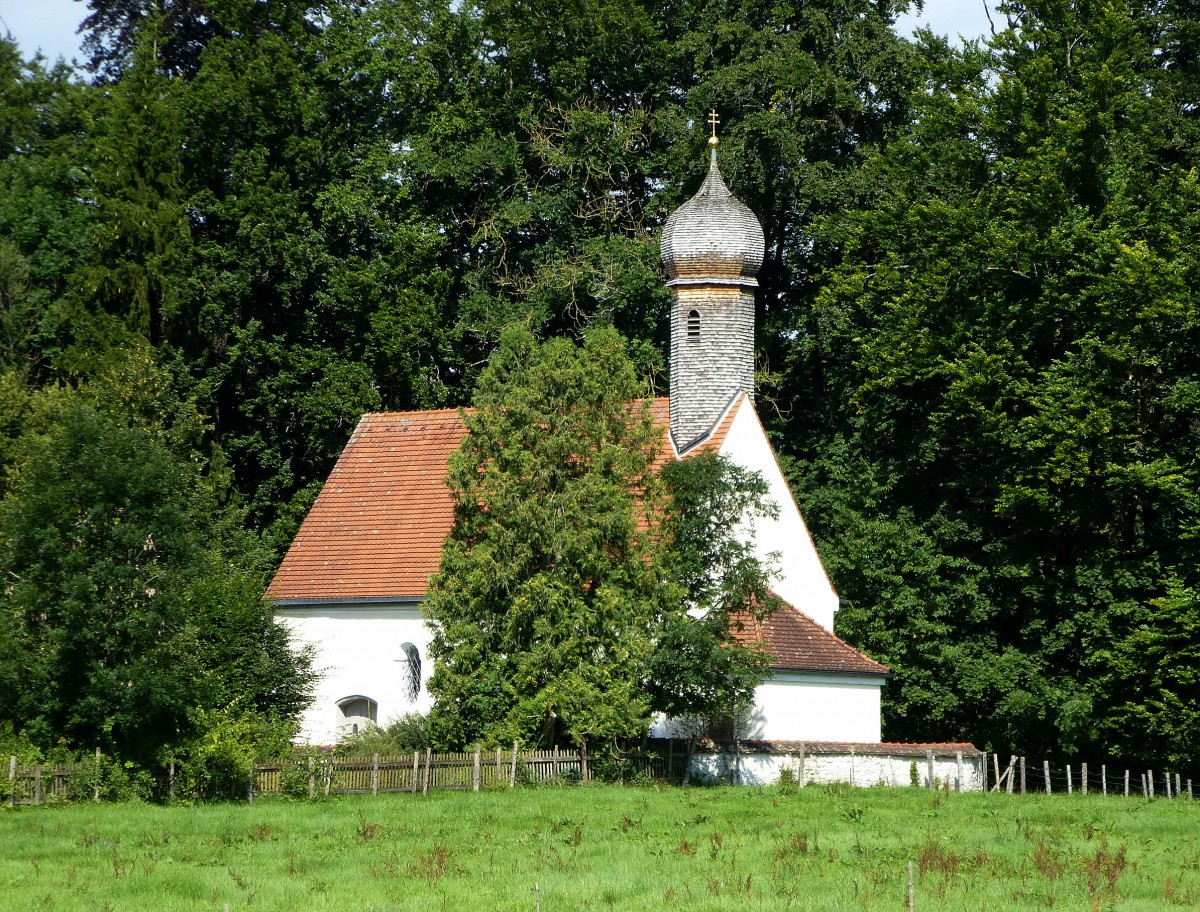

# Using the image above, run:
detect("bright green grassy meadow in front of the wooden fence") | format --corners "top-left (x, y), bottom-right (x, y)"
top-left (0, 785), bottom-right (1200, 912)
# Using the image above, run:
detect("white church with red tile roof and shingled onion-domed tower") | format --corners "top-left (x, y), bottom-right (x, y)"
top-left (266, 139), bottom-right (890, 744)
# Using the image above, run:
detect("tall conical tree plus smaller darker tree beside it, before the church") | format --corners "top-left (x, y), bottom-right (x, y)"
top-left (425, 325), bottom-right (774, 752)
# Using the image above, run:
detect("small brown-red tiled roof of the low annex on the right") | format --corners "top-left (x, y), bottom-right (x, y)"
top-left (732, 601), bottom-right (892, 676)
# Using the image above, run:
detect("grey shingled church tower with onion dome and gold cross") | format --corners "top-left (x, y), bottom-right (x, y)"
top-left (661, 112), bottom-right (766, 452)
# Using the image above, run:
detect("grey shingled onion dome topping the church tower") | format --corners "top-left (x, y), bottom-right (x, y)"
top-left (661, 137), bottom-right (766, 287)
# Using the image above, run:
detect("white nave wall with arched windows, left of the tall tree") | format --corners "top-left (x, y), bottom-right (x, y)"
top-left (275, 602), bottom-right (433, 744)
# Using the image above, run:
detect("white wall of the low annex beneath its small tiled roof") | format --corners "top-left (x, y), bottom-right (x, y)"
top-left (738, 671), bottom-right (884, 744)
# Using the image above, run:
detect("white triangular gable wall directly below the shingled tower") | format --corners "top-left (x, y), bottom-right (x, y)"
top-left (719, 397), bottom-right (838, 632)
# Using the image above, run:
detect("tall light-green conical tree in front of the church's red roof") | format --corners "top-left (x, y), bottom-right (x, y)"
top-left (425, 326), bottom-right (680, 746)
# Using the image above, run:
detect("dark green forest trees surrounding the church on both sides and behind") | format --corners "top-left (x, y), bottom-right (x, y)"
top-left (0, 0), bottom-right (1200, 777)
